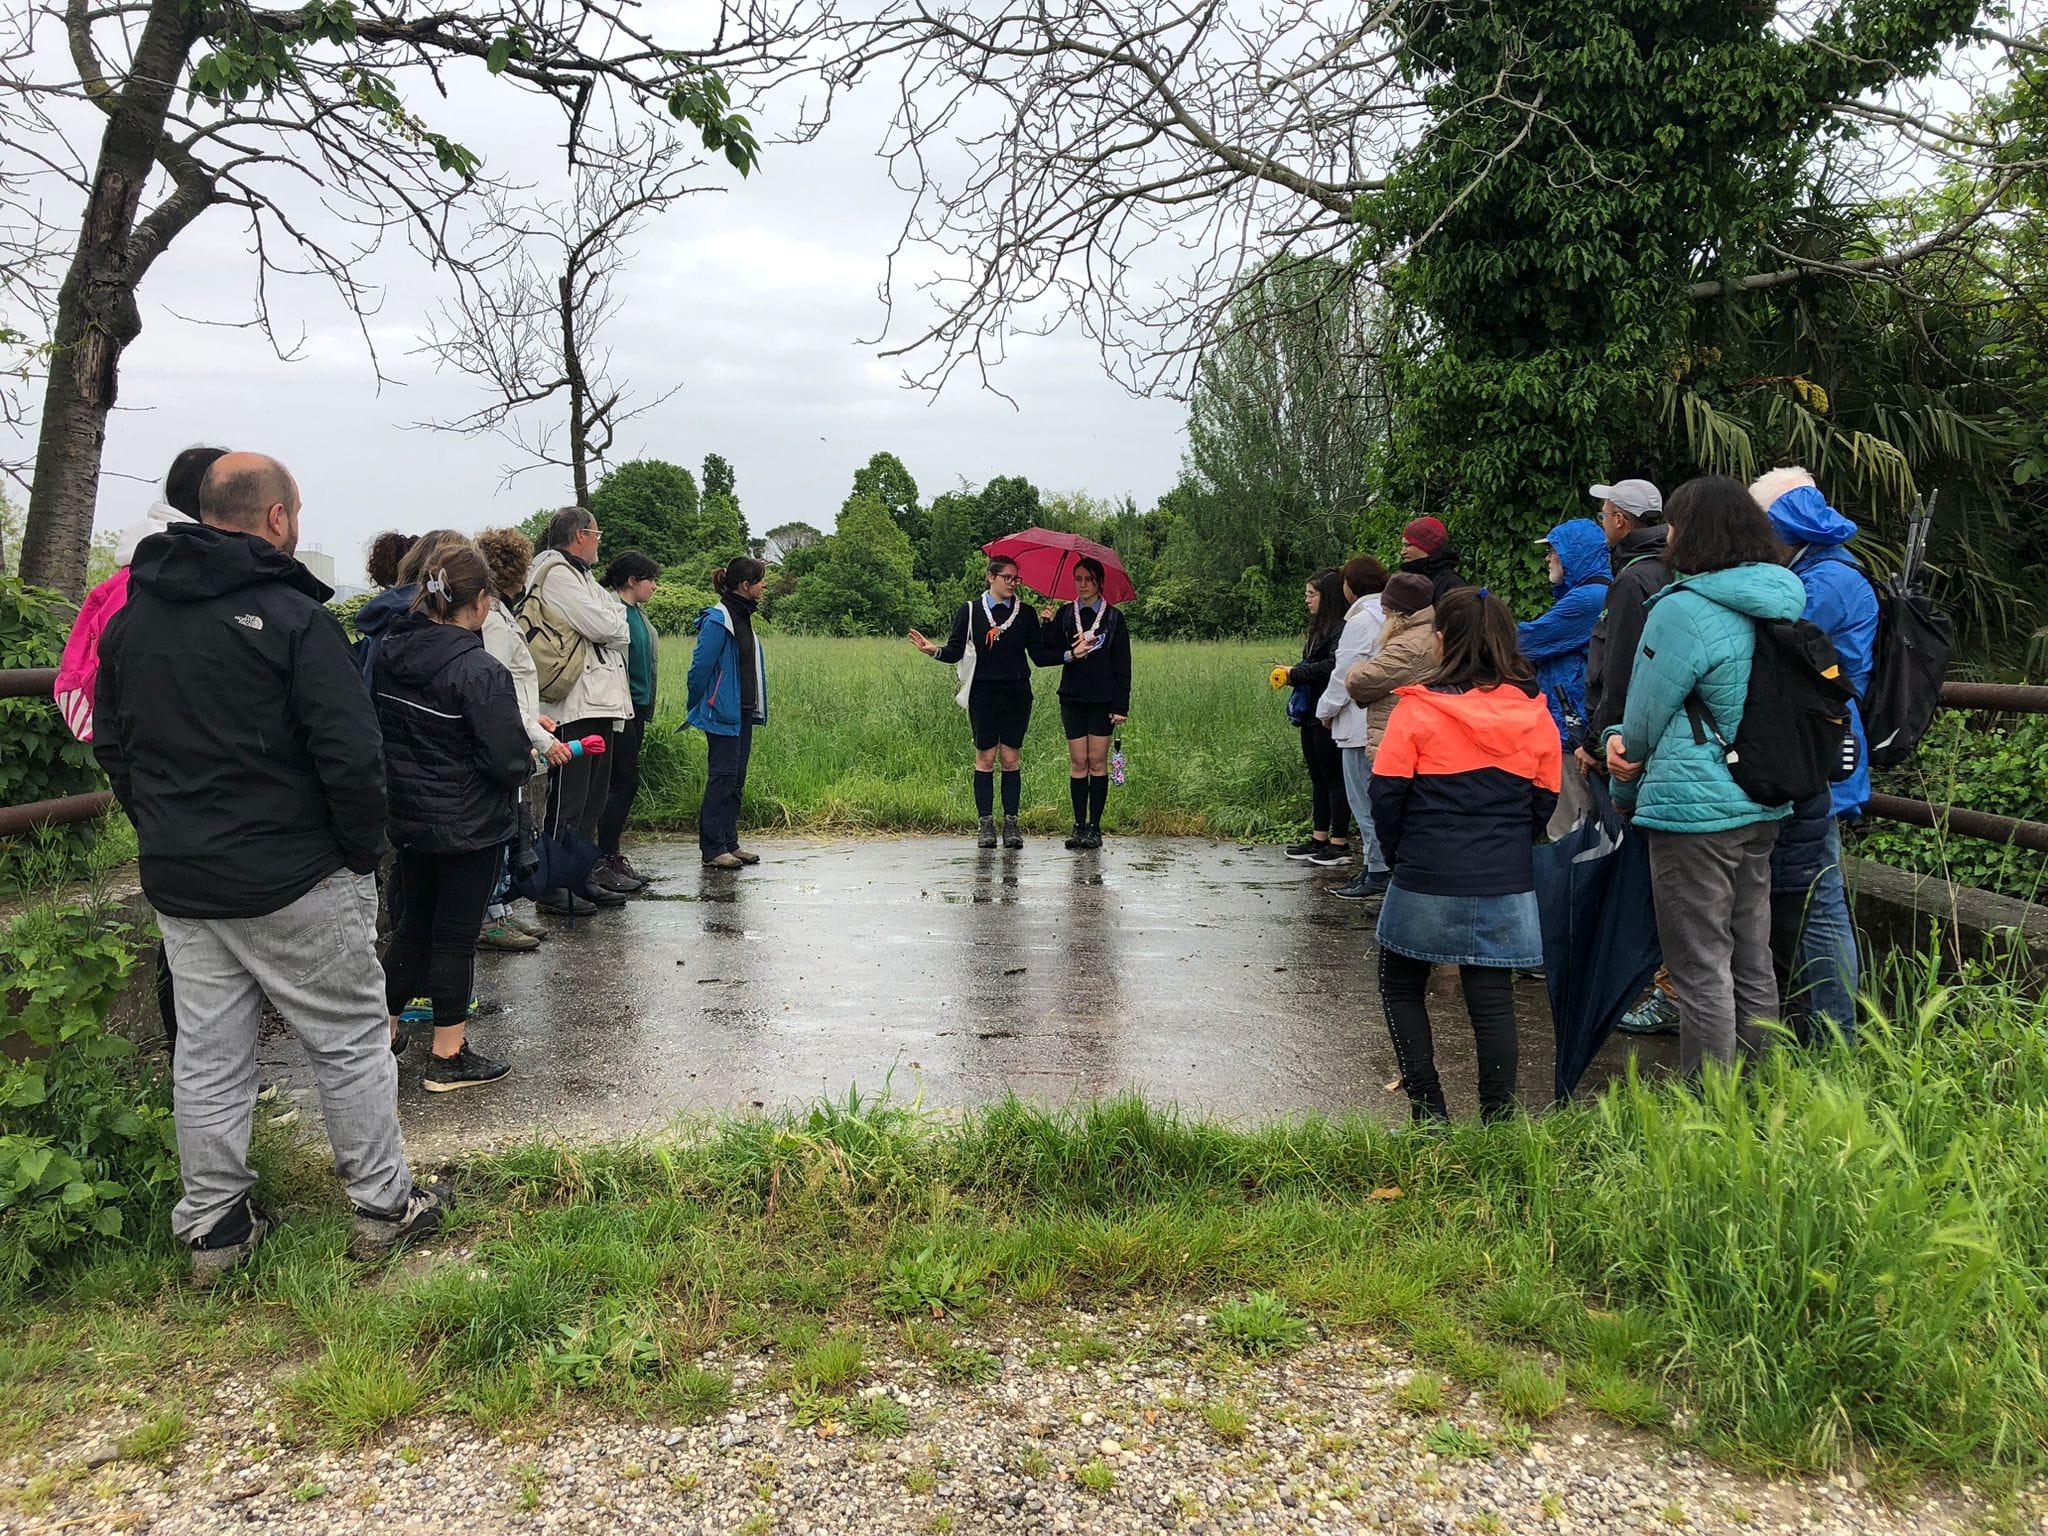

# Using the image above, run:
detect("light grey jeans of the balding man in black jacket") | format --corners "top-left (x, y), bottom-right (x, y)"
top-left (158, 868), bottom-right (412, 1243)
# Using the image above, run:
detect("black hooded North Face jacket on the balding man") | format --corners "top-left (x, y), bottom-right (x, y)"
top-left (92, 522), bottom-right (385, 918)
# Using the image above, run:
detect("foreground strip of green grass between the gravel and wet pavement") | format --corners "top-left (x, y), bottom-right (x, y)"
top-left (0, 969), bottom-right (2048, 1489)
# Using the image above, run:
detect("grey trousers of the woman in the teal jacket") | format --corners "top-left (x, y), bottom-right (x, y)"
top-left (1645, 821), bottom-right (1778, 1077)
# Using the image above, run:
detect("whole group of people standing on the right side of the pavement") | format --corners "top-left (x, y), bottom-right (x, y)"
top-left (1272, 469), bottom-right (1878, 1118)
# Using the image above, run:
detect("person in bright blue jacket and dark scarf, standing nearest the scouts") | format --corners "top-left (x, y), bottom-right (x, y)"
top-left (688, 555), bottom-right (768, 868)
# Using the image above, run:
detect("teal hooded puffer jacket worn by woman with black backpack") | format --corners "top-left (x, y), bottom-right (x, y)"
top-left (1608, 565), bottom-right (1806, 831)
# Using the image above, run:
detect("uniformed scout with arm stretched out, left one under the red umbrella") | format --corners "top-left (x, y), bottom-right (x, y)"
top-left (909, 555), bottom-right (1042, 848)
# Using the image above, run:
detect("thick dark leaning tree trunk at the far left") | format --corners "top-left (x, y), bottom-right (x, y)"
top-left (20, 0), bottom-right (205, 598)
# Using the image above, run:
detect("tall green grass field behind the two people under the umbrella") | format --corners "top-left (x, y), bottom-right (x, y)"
top-left (635, 635), bottom-right (1309, 840)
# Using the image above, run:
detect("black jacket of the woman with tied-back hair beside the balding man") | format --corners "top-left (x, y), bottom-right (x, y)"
top-left (375, 612), bottom-right (532, 854)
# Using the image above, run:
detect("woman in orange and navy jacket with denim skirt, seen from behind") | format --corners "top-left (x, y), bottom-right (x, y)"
top-left (1370, 586), bottom-right (1563, 1120)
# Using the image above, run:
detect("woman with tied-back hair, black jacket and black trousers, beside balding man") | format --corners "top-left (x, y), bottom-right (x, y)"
top-left (373, 539), bottom-right (535, 1094)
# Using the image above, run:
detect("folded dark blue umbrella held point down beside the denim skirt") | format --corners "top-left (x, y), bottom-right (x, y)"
top-left (1536, 774), bottom-right (1663, 1100)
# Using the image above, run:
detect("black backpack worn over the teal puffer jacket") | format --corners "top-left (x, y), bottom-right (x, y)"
top-left (1686, 618), bottom-right (1855, 805)
